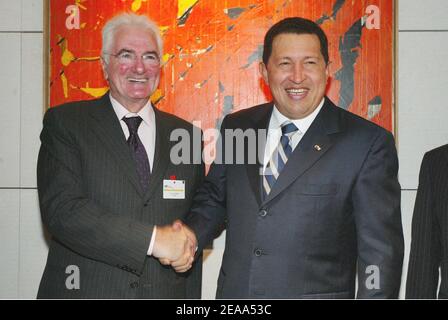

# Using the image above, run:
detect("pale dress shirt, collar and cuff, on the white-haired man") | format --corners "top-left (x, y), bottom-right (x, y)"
top-left (109, 95), bottom-right (157, 256)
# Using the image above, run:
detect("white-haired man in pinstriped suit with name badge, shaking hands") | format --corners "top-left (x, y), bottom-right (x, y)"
top-left (37, 14), bottom-right (204, 299)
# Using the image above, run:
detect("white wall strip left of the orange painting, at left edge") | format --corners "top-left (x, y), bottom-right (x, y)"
top-left (0, 0), bottom-right (48, 298)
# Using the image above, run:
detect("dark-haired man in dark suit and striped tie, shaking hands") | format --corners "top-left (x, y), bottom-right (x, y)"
top-left (184, 18), bottom-right (403, 298)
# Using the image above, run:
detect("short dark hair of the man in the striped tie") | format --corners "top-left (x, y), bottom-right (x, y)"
top-left (263, 17), bottom-right (329, 65)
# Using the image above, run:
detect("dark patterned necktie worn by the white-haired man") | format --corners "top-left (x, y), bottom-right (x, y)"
top-left (123, 116), bottom-right (151, 191)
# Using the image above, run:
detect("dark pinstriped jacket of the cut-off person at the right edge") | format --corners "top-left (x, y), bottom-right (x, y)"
top-left (406, 145), bottom-right (448, 299)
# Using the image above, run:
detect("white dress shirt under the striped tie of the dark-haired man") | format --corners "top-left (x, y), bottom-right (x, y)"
top-left (263, 98), bottom-right (325, 172)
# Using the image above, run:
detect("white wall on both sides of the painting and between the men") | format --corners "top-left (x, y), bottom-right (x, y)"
top-left (0, 0), bottom-right (448, 299)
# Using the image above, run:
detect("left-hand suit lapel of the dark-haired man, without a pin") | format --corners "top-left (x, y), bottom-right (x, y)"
top-left (246, 103), bottom-right (273, 205)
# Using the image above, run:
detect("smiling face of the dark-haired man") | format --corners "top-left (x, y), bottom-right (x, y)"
top-left (260, 33), bottom-right (329, 119)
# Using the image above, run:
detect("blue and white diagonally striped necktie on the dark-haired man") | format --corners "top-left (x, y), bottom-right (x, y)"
top-left (263, 122), bottom-right (299, 198)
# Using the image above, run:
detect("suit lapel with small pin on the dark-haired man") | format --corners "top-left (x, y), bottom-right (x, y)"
top-left (263, 98), bottom-right (342, 204)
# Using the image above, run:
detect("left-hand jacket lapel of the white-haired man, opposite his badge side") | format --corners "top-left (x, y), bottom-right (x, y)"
top-left (90, 93), bottom-right (143, 196)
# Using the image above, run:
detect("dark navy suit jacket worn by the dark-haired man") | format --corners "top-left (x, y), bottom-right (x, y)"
top-left (186, 99), bottom-right (403, 298)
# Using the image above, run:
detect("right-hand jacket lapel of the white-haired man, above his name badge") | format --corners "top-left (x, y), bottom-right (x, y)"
top-left (145, 108), bottom-right (174, 199)
